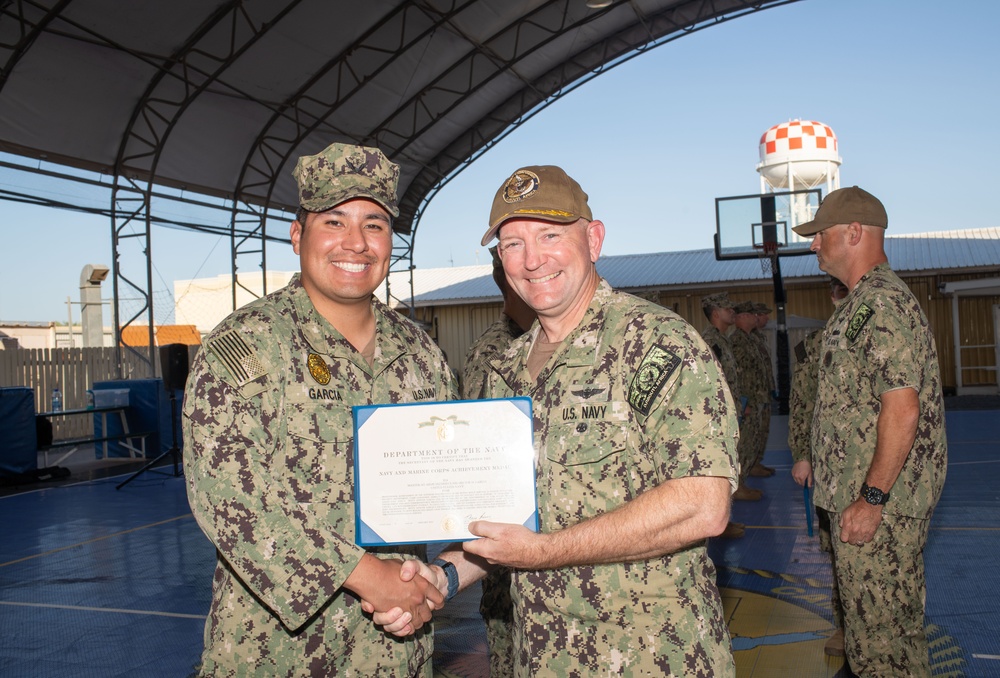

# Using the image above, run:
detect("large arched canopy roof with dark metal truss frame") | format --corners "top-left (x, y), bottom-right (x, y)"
top-left (0, 0), bottom-right (797, 376)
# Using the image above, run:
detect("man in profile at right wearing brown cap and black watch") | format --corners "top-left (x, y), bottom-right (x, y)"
top-left (794, 186), bottom-right (947, 676)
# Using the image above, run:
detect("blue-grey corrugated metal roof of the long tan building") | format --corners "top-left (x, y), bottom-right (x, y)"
top-left (404, 228), bottom-right (1000, 306)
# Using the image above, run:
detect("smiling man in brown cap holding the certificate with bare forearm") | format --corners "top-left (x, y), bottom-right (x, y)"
top-left (376, 166), bottom-right (737, 678)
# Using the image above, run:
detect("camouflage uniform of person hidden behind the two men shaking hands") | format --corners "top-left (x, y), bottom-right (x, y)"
top-left (462, 313), bottom-right (524, 678)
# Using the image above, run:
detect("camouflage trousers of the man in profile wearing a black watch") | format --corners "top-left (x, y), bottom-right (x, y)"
top-left (830, 513), bottom-right (931, 678)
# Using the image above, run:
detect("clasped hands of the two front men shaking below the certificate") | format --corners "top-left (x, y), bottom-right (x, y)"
top-left (344, 553), bottom-right (444, 636)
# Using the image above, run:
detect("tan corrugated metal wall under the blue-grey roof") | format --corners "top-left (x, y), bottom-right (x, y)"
top-left (417, 271), bottom-right (1000, 392)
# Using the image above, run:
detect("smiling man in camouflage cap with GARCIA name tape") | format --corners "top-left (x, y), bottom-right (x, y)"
top-left (184, 144), bottom-right (455, 677)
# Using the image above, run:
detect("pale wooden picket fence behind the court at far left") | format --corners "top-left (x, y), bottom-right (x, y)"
top-left (0, 346), bottom-right (200, 439)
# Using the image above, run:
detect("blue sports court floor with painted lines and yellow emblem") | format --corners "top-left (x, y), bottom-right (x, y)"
top-left (0, 409), bottom-right (1000, 678)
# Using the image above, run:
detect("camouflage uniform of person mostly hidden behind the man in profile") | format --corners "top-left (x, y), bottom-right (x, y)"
top-left (788, 330), bottom-right (844, 629)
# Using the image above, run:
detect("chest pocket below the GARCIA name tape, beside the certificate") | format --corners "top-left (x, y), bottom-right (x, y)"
top-left (279, 412), bottom-right (354, 504)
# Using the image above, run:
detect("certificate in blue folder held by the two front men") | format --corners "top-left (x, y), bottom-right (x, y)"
top-left (352, 398), bottom-right (538, 546)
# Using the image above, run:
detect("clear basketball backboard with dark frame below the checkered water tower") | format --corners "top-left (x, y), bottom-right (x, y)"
top-left (715, 188), bottom-right (821, 261)
